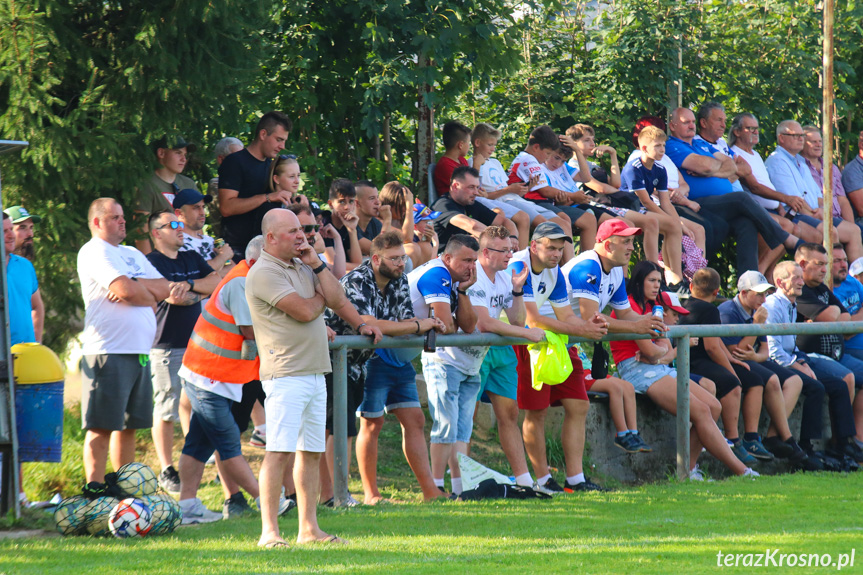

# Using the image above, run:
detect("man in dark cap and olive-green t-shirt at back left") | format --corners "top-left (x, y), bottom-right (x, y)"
top-left (135, 137), bottom-right (197, 255)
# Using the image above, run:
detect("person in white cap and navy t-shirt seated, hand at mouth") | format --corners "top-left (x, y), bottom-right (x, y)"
top-left (719, 270), bottom-right (808, 462)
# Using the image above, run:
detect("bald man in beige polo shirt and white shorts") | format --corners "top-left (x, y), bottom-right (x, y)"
top-left (246, 209), bottom-right (381, 548)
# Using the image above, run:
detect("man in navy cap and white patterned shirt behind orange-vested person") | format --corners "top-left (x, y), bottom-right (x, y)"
top-left (172, 188), bottom-right (234, 277)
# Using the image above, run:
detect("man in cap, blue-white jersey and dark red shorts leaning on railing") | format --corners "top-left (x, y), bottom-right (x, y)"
top-left (508, 222), bottom-right (608, 493)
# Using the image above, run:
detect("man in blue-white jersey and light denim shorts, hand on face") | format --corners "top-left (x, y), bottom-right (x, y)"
top-left (408, 234), bottom-right (485, 494)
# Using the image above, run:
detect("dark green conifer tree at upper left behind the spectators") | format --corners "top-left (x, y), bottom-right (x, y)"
top-left (0, 0), bottom-right (270, 352)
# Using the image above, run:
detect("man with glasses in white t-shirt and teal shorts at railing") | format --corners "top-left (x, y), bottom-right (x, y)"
top-left (470, 226), bottom-right (545, 487)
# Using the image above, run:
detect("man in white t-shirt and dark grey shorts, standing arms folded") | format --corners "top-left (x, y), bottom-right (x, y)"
top-left (78, 198), bottom-right (176, 483)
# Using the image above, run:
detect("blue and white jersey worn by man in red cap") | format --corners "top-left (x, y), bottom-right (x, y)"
top-left (563, 250), bottom-right (630, 317)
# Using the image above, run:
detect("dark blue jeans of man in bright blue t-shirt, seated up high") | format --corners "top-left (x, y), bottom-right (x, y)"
top-left (696, 192), bottom-right (788, 274)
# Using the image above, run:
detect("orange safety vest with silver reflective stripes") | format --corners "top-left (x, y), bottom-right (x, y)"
top-left (183, 260), bottom-right (261, 384)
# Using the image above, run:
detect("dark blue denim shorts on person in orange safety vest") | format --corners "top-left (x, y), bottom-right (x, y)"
top-left (183, 381), bottom-right (242, 461)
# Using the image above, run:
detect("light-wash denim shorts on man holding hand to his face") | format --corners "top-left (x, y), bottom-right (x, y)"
top-left (422, 357), bottom-right (480, 443)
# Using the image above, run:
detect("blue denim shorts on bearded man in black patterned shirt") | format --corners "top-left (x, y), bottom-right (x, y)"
top-left (357, 354), bottom-right (420, 419)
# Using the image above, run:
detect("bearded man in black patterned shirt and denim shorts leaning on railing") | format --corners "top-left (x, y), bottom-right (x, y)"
top-left (321, 232), bottom-right (445, 505)
